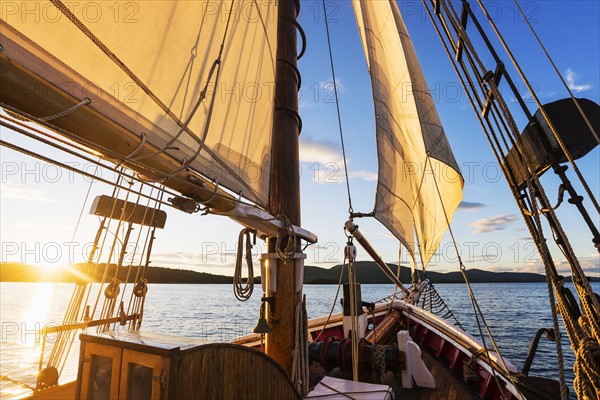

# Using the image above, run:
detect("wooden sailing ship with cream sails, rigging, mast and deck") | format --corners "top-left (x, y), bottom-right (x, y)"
top-left (0, 0), bottom-right (600, 399)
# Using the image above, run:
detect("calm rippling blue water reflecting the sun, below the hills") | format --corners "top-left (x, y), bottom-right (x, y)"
top-left (0, 282), bottom-right (600, 398)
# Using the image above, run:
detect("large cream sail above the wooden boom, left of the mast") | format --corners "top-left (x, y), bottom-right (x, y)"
top-left (0, 0), bottom-right (277, 205)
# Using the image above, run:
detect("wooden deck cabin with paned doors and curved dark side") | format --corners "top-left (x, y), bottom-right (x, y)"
top-left (76, 331), bottom-right (300, 400)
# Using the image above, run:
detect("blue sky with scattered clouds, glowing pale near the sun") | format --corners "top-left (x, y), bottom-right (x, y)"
top-left (0, 0), bottom-right (600, 275)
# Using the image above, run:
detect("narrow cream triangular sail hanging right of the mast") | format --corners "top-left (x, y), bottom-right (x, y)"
top-left (353, 0), bottom-right (464, 267)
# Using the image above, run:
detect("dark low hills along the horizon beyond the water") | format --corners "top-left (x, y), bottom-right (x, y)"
top-left (0, 261), bottom-right (600, 284)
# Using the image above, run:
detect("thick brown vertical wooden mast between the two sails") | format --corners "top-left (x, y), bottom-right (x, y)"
top-left (266, 0), bottom-right (303, 375)
